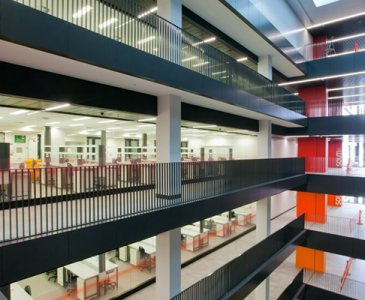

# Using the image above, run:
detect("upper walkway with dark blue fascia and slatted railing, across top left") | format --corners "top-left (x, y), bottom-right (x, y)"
top-left (0, 0), bottom-right (305, 123)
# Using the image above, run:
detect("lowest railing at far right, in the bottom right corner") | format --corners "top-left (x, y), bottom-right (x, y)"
top-left (304, 270), bottom-right (365, 300)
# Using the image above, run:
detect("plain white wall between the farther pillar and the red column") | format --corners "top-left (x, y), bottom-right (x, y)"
top-left (271, 137), bottom-right (298, 218)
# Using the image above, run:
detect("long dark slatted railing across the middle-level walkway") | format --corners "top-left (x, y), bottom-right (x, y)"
top-left (0, 158), bottom-right (304, 243)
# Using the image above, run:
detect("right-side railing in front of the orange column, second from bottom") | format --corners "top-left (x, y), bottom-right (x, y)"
top-left (305, 213), bottom-right (365, 240)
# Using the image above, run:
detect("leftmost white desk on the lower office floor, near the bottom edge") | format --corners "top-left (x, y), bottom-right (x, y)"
top-left (64, 261), bottom-right (100, 300)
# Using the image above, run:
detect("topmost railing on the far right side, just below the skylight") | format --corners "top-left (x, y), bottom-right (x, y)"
top-left (303, 33), bottom-right (365, 61)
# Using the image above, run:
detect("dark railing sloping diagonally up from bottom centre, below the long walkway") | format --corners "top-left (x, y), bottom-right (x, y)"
top-left (171, 215), bottom-right (304, 300)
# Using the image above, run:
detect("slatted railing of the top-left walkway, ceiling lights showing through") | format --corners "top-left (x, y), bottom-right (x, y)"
top-left (9, 0), bottom-right (305, 114)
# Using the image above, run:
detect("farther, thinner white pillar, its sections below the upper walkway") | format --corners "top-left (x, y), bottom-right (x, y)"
top-left (255, 120), bottom-right (271, 300)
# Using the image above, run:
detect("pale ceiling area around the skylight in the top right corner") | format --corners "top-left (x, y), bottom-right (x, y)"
top-left (286, 0), bottom-right (365, 27)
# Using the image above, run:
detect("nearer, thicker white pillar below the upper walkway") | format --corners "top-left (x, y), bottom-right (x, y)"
top-left (156, 95), bottom-right (181, 300)
